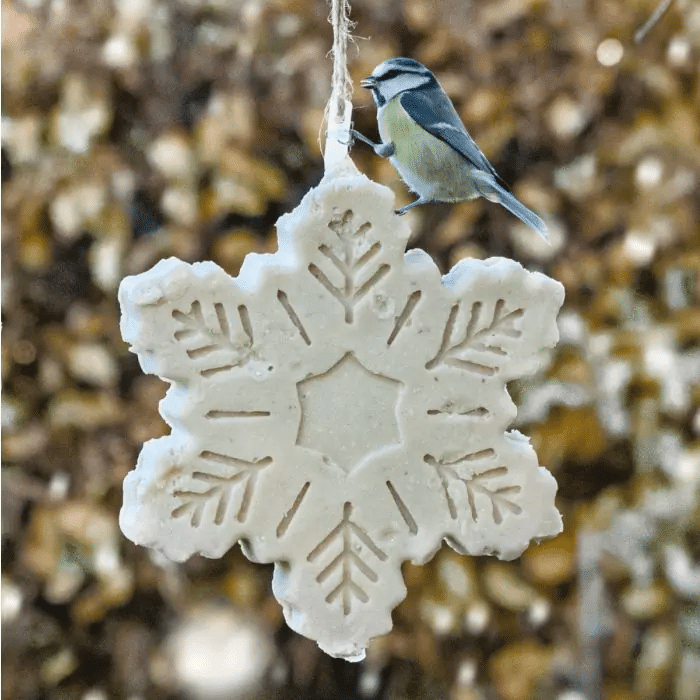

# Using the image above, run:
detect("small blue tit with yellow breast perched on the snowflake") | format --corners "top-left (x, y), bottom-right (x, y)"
top-left (351, 57), bottom-right (547, 240)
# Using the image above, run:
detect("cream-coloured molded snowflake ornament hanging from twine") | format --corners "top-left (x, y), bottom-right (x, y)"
top-left (119, 158), bottom-right (563, 660)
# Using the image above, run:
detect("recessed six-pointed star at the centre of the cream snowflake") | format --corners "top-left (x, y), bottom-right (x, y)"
top-left (296, 352), bottom-right (402, 474)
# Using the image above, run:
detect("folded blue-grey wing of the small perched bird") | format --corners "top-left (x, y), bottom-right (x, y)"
top-left (399, 87), bottom-right (502, 182)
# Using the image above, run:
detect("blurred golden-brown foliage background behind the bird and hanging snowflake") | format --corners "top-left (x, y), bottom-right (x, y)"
top-left (1, 0), bottom-right (700, 700)
